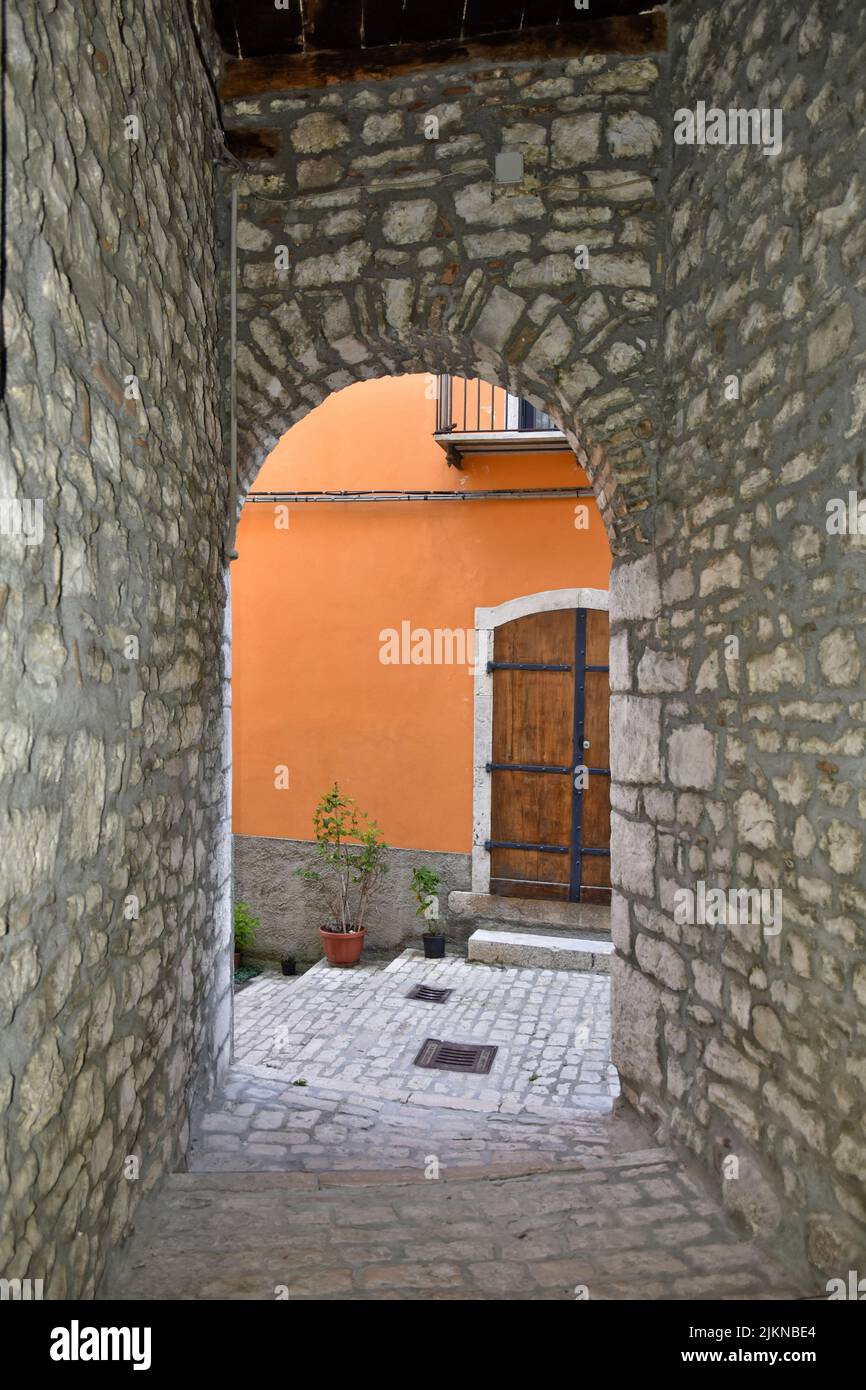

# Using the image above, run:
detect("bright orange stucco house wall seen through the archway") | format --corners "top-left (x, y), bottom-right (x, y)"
top-left (232, 377), bottom-right (610, 852)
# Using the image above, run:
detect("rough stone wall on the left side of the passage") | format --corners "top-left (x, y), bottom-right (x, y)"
top-left (0, 0), bottom-right (231, 1298)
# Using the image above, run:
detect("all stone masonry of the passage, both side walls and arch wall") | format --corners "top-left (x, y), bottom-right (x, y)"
top-left (0, 0), bottom-right (866, 1297)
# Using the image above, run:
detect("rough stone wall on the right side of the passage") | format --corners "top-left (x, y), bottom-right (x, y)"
top-left (612, 0), bottom-right (866, 1276)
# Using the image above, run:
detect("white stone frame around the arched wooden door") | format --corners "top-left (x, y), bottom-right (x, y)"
top-left (473, 589), bottom-right (607, 894)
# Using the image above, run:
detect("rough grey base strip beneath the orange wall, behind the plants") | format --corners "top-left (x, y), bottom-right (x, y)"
top-left (235, 835), bottom-right (471, 963)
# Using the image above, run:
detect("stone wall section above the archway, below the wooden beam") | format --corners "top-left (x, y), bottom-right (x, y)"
top-left (225, 44), bottom-right (662, 550)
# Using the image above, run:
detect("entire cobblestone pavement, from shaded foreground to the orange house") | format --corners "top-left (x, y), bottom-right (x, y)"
top-left (99, 951), bottom-right (801, 1301)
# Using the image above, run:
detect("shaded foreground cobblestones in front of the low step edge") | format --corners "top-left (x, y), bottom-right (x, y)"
top-left (99, 1145), bottom-right (802, 1301)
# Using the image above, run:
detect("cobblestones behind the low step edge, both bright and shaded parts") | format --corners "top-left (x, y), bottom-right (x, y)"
top-left (189, 951), bottom-right (619, 1173)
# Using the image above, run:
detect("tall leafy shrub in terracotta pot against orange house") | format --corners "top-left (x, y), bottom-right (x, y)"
top-left (296, 783), bottom-right (388, 966)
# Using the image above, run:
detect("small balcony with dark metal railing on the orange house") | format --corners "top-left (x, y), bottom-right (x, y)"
top-left (434, 375), bottom-right (569, 468)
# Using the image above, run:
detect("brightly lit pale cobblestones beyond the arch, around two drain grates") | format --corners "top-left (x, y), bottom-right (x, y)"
top-left (235, 949), bottom-right (619, 1115)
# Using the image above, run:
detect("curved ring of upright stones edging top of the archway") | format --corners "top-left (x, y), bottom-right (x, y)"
top-left (230, 322), bottom-right (655, 556)
